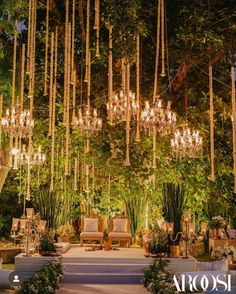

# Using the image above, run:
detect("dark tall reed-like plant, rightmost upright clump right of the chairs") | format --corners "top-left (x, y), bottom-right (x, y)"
top-left (162, 183), bottom-right (186, 245)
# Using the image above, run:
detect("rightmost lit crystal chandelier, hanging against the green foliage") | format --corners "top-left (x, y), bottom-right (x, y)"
top-left (171, 126), bottom-right (203, 158)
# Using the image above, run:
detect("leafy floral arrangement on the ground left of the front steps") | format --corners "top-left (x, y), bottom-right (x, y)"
top-left (18, 259), bottom-right (63, 294)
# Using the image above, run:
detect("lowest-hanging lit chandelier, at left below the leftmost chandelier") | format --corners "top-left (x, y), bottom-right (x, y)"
top-left (11, 145), bottom-right (46, 170)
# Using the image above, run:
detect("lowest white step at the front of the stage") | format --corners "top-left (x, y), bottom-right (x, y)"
top-left (62, 272), bottom-right (143, 284)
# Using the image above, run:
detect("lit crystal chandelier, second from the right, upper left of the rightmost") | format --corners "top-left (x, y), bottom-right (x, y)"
top-left (140, 98), bottom-right (176, 134)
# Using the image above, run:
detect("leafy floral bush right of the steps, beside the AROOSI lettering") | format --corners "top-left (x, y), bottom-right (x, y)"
top-left (143, 259), bottom-right (189, 294)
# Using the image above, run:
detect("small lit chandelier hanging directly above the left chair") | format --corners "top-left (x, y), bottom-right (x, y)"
top-left (74, 106), bottom-right (102, 132)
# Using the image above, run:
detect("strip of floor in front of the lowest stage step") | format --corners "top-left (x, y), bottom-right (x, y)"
top-left (57, 284), bottom-right (149, 294)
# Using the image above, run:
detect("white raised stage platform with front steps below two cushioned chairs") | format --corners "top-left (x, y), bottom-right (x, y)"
top-left (15, 246), bottom-right (196, 284)
